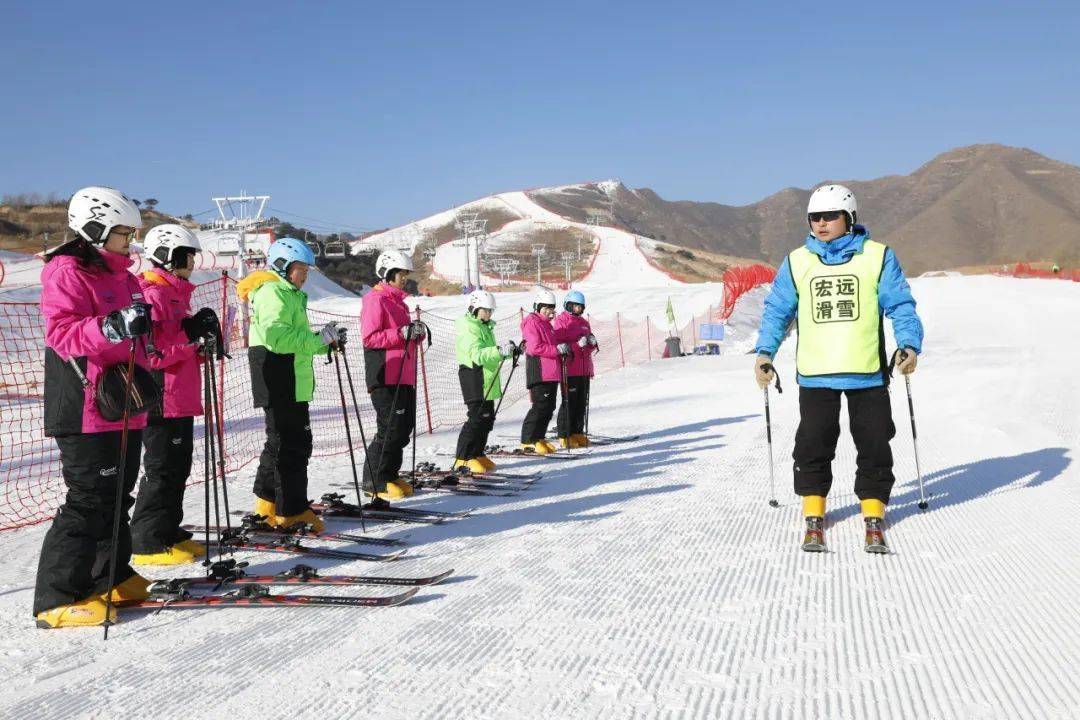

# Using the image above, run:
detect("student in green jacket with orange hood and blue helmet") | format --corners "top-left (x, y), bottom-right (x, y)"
top-left (237, 237), bottom-right (346, 531)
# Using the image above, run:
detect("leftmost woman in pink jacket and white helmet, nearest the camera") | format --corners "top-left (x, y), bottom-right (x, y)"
top-left (33, 187), bottom-right (150, 627)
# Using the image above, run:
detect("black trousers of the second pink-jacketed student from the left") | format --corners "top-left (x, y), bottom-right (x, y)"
top-left (132, 418), bottom-right (195, 555)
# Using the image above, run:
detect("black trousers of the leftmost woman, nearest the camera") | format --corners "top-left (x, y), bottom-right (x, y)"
top-left (33, 430), bottom-right (143, 614)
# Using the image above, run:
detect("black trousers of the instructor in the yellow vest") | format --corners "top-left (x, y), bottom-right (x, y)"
top-left (792, 385), bottom-right (896, 503)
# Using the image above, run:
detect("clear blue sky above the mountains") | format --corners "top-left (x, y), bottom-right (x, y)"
top-left (0, 1), bottom-right (1080, 230)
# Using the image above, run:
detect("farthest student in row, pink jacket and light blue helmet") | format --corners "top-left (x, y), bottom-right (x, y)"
top-left (555, 290), bottom-right (596, 448)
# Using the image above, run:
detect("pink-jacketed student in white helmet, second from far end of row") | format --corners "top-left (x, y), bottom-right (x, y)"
top-left (522, 287), bottom-right (570, 454)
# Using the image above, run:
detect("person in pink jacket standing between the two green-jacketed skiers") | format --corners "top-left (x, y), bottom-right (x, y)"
top-left (360, 250), bottom-right (416, 506)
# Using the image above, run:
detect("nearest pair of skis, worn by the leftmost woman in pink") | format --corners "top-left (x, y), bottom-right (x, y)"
top-left (124, 560), bottom-right (454, 611)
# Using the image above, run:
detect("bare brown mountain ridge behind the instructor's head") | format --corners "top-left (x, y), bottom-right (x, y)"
top-left (529, 145), bottom-right (1080, 274)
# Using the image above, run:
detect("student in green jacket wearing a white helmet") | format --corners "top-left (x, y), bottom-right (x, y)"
top-left (454, 290), bottom-right (517, 473)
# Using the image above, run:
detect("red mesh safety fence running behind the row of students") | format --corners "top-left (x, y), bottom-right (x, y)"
top-left (0, 267), bottom-right (767, 530)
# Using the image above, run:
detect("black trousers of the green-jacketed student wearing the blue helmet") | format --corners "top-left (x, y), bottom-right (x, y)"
top-left (253, 402), bottom-right (311, 515)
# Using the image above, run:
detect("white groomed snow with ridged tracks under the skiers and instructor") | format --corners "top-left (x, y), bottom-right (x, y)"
top-left (0, 277), bottom-right (1080, 719)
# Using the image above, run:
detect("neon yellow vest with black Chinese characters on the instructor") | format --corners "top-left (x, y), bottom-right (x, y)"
top-left (787, 240), bottom-right (886, 377)
